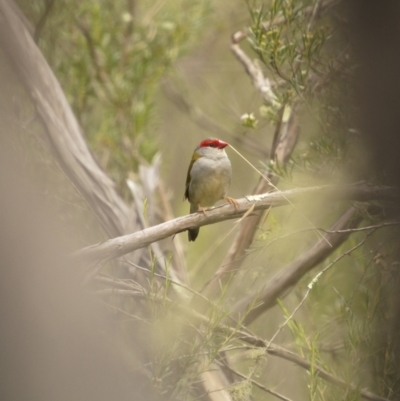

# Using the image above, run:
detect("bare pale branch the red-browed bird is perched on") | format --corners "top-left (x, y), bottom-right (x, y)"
top-left (75, 184), bottom-right (399, 264)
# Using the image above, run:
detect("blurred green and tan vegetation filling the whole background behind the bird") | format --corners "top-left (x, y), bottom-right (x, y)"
top-left (3, 0), bottom-right (400, 401)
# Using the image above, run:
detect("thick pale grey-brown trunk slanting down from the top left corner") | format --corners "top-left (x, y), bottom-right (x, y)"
top-left (0, 1), bottom-right (137, 236)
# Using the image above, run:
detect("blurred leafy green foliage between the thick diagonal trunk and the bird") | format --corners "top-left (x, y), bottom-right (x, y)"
top-left (19, 0), bottom-right (211, 192)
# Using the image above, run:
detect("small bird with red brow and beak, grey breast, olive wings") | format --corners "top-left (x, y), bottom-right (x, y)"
top-left (184, 138), bottom-right (238, 242)
